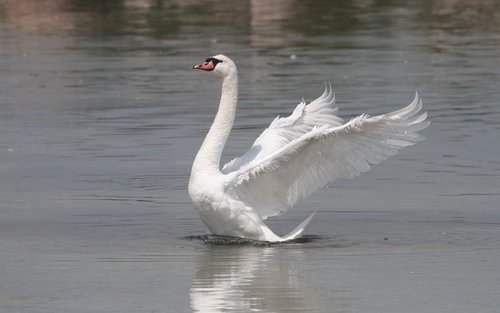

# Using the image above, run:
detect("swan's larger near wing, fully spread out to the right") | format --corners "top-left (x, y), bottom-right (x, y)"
top-left (226, 94), bottom-right (429, 218)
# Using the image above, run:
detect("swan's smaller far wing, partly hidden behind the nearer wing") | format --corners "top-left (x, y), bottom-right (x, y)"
top-left (222, 84), bottom-right (344, 174)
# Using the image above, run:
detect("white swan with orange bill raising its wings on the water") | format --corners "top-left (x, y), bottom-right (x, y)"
top-left (189, 54), bottom-right (429, 242)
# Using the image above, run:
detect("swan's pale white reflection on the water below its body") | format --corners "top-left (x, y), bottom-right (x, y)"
top-left (191, 246), bottom-right (318, 313)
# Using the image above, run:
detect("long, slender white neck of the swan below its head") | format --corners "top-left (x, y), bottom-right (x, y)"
top-left (192, 71), bottom-right (238, 174)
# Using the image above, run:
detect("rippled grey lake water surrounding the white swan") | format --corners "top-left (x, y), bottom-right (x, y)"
top-left (0, 0), bottom-right (500, 312)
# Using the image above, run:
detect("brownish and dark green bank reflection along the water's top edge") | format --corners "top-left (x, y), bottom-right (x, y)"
top-left (0, 0), bottom-right (499, 39)
